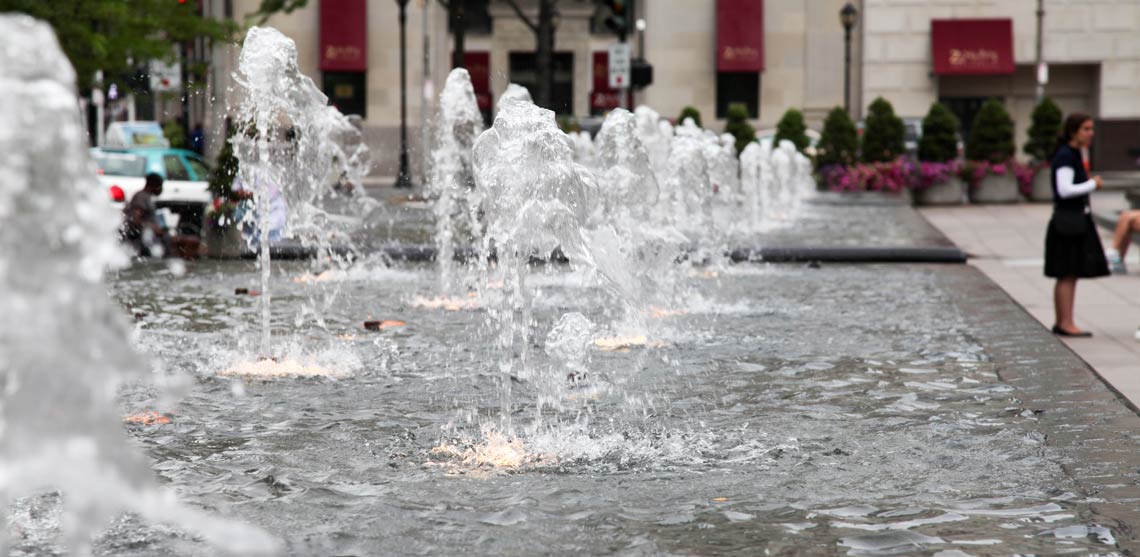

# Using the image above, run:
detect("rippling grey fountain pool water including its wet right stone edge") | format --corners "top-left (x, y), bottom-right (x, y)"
top-left (4, 262), bottom-right (1140, 555)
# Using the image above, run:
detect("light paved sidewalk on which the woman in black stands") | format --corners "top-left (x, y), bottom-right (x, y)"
top-left (920, 191), bottom-right (1140, 407)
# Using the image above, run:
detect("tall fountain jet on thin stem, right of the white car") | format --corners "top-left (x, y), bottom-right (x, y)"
top-left (233, 27), bottom-right (375, 357)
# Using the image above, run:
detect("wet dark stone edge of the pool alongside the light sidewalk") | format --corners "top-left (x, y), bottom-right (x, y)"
top-left (941, 267), bottom-right (1140, 555)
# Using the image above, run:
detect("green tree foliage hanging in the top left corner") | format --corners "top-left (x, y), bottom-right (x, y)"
top-left (0, 0), bottom-right (237, 92)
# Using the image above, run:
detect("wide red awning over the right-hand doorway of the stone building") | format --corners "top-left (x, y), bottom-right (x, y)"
top-left (930, 18), bottom-right (1013, 75)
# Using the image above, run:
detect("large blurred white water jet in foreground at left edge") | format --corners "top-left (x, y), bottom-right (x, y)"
top-left (0, 15), bottom-right (278, 555)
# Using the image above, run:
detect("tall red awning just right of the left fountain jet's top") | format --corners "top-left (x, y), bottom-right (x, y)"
top-left (320, 0), bottom-right (368, 72)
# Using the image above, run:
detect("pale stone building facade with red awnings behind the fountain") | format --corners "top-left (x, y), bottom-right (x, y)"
top-left (211, 0), bottom-right (1140, 177)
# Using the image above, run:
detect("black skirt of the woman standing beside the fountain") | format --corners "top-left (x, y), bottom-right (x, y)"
top-left (1045, 211), bottom-right (1108, 278)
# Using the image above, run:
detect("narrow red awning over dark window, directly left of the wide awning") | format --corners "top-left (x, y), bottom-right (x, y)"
top-left (716, 0), bottom-right (764, 72)
